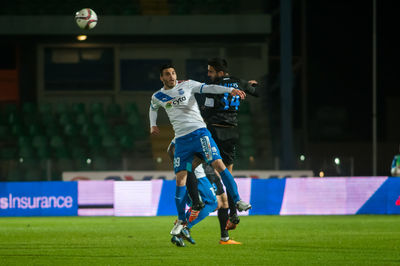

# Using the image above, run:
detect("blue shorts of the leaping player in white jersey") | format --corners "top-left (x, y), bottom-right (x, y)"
top-left (174, 128), bottom-right (221, 173)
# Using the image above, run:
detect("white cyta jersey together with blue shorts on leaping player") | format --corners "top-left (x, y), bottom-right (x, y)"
top-left (149, 80), bottom-right (232, 173)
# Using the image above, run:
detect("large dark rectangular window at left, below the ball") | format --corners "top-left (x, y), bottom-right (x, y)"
top-left (44, 48), bottom-right (114, 91)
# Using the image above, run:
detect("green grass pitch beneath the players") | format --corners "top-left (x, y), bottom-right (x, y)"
top-left (0, 216), bottom-right (400, 265)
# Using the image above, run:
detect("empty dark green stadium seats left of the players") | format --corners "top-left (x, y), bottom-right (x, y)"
top-left (0, 102), bottom-right (147, 181)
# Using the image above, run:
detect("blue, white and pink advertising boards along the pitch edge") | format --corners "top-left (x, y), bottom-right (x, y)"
top-left (0, 177), bottom-right (400, 216)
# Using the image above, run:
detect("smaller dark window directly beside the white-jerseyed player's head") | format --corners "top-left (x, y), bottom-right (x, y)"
top-left (120, 59), bottom-right (172, 91)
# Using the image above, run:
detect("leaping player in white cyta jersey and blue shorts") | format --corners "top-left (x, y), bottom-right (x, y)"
top-left (149, 65), bottom-right (251, 235)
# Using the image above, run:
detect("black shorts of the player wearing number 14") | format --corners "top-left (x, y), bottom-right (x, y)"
top-left (207, 125), bottom-right (239, 165)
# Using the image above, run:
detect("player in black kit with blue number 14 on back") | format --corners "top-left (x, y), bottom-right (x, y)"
top-left (197, 58), bottom-right (258, 244)
